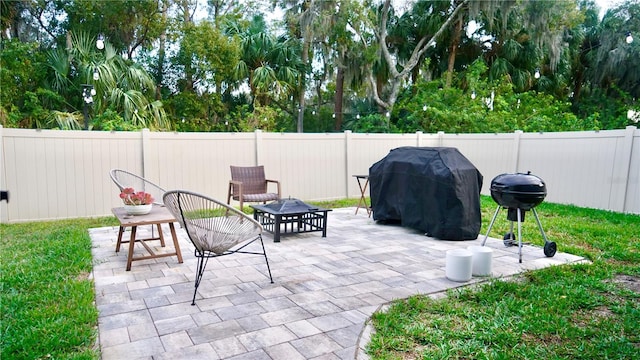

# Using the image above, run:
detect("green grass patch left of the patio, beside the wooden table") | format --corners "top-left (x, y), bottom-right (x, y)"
top-left (0, 218), bottom-right (117, 360)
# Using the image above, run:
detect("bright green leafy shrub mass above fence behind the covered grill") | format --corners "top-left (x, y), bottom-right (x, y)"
top-left (392, 61), bottom-right (601, 133)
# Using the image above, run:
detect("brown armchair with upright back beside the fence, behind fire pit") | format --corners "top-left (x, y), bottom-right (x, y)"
top-left (227, 165), bottom-right (280, 211)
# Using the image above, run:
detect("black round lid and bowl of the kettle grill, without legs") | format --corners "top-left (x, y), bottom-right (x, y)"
top-left (490, 172), bottom-right (547, 211)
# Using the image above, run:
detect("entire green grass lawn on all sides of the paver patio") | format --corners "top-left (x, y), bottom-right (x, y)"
top-left (0, 197), bottom-right (640, 359)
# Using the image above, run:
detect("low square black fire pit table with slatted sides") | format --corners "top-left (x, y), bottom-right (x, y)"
top-left (250, 199), bottom-right (331, 242)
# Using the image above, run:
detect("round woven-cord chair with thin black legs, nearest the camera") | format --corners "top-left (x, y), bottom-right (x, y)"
top-left (164, 190), bottom-right (273, 305)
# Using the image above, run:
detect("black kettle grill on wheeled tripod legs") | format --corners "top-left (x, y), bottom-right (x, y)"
top-left (482, 171), bottom-right (556, 262)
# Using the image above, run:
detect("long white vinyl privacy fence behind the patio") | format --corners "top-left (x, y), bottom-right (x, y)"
top-left (0, 126), bottom-right (640, 223)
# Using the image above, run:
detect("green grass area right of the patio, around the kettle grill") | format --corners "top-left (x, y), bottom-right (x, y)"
top-left (367, 197), bottom-right (640, 359)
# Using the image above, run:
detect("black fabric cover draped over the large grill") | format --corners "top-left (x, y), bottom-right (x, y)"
top-left (369, 147), bottom-right (482, 240)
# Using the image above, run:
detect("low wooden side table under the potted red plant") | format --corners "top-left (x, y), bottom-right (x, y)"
top-left (111, 204), bottom-right (182, 271)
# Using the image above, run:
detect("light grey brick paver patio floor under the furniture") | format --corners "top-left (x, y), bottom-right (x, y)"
top-left (90, 208), bottom-right (583, 360)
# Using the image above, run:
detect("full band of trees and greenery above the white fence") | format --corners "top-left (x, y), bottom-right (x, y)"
top-left (0, 0), bottom-right (640, 133)
